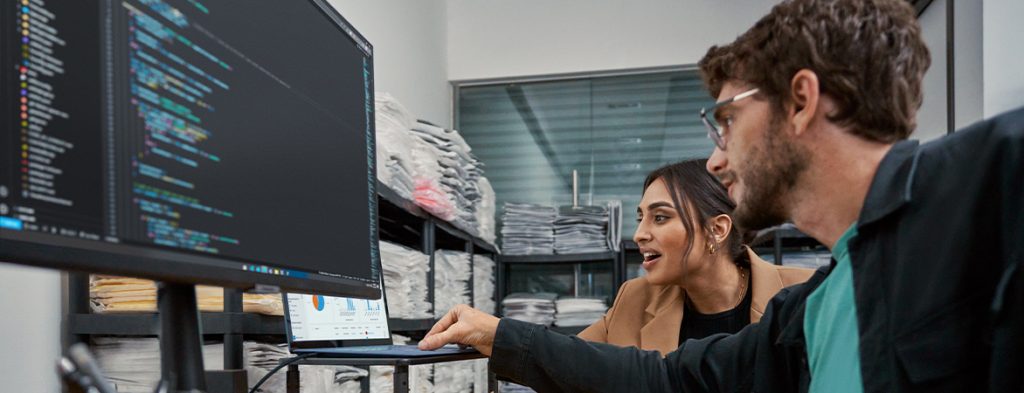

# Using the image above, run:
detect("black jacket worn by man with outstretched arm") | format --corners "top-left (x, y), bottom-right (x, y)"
top-left (490, 105), bottom-right (1024, 392)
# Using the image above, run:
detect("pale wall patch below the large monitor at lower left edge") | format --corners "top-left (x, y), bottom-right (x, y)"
top-left (0, 263), bottom-right (61, 392)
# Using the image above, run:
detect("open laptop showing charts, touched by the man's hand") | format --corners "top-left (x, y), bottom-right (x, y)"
top-left (283, 282), bottom-right (479, 358)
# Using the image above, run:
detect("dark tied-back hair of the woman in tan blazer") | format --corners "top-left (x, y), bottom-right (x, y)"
top-left (643, 159), bottom-right (751, 267)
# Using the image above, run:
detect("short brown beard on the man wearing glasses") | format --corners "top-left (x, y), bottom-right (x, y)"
top-left (732, 115), bottom-right (810, 230)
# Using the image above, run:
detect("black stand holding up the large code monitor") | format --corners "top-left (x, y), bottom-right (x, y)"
top-left (157, 282), bottom-right (207, 393)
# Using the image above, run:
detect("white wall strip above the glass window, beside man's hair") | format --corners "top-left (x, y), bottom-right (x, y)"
top-left (447, 0), bottom-right (777, 81)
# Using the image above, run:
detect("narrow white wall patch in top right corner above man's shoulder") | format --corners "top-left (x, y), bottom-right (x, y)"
top-left (983, 0), bottom-right (1024, 118)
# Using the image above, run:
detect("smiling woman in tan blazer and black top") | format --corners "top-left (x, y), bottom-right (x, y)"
top-left (579, 160), bottom-right (813, 355)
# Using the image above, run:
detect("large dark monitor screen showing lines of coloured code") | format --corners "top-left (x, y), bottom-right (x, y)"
top-left (0, 0), bottom-right (380, 298)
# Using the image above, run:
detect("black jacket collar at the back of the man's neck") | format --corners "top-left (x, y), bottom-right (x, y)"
top-left (857, 140), bottom-right (920, 229)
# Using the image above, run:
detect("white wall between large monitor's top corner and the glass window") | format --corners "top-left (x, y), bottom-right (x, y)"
top-left (329, 0), bottom-right (452, 127)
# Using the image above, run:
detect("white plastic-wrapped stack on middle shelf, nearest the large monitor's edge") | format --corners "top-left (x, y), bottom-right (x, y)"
top-left (380, 241), bottom-right (433, 319)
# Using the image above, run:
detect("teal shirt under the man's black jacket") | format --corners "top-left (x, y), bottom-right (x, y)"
top-left (804, 224), bottom-right (864, 393)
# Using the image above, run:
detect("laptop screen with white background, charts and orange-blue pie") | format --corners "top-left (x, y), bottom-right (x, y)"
top-left (288, 294), bottom-right (390, 342)
